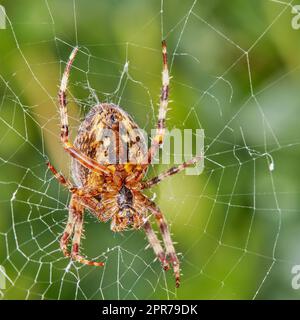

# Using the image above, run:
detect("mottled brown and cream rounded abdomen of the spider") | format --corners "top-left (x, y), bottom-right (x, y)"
top-left (72, 103), bottom-right (147, 186)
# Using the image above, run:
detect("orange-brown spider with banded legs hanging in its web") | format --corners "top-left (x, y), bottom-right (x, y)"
top-left (47, 41), bottom-right (200, 287)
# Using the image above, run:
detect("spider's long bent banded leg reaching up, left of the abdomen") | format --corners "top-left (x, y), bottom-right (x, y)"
top-left (58, 47), bottom-right (111, 175)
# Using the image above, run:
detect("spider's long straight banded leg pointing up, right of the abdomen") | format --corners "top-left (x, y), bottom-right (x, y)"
top-left (145, 41), bottom-right (170, 164)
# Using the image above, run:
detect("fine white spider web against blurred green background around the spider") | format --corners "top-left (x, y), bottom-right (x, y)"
top-left (0, 0), bottom-right (300, 299)
